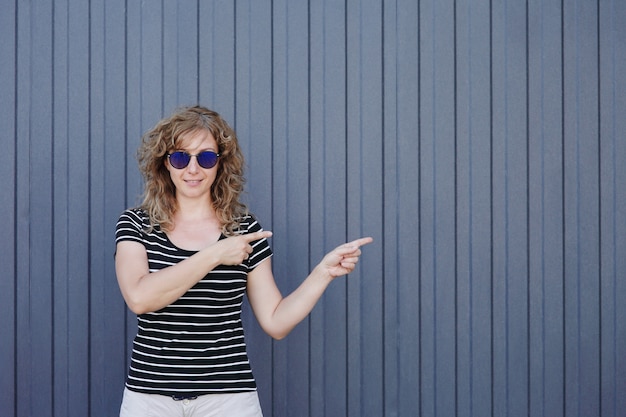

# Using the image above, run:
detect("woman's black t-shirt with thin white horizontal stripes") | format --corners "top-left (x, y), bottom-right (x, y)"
top-left (115, 209), bottom-right (272, 395)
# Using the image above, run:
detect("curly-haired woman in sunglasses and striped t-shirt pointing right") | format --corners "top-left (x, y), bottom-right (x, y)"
top-left (115, 106), bottom-right (372, 417)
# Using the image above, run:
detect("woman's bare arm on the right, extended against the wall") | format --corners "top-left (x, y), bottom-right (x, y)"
top-left (247, 237), bottom-right (372, 340)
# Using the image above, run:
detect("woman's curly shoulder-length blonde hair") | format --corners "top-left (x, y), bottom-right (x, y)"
top-left (137, 106), bottom-right (248, 235)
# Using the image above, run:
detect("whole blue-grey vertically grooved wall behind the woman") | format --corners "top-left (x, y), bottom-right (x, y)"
top-left (0, 0), bottom-right (626, 417)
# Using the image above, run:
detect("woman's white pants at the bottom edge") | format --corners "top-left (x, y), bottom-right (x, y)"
top-left (120, 388), bottom-right (263, 417)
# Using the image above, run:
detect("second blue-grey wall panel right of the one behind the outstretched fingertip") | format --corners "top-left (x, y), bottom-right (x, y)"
top-left (419, 1), bottom-right (456, 416)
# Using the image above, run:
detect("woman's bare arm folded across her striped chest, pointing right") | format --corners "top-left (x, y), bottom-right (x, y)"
top-left (115, 231), bottom-right (271, 314)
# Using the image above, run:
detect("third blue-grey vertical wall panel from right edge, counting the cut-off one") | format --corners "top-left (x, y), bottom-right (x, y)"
top-left (528, 1), bottom-right (565, 416)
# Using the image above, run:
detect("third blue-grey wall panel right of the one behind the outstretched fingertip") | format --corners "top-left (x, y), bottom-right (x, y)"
top-left (456, 1), bottom-right (493, 416)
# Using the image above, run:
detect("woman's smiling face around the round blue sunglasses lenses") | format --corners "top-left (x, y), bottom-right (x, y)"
top-left (165, 129), bottom-right (219, 201)
